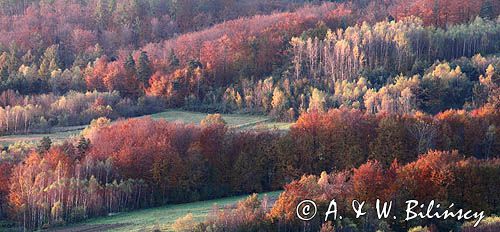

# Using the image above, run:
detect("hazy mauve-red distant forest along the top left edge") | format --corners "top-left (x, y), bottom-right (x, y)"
top-left (0, 0), bottom-right (305, 53)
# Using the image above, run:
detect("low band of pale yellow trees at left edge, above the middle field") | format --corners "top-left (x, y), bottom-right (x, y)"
top-left (0, 90), bottom-right (165, 135)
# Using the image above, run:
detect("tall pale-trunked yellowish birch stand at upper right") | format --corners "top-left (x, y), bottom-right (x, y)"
top-left (290, 17), bottom-right (500, 85)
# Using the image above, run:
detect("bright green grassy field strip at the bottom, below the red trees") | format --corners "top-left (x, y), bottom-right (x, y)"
top-left (50, 191), bottom-right (281, 232)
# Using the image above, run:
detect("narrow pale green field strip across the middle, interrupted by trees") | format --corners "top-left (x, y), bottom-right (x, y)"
top-left (0, 110), bottom-right (291, 146)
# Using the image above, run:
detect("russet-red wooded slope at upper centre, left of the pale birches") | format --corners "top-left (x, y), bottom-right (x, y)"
top-left (143, 3), bottom-right (350, 89)
